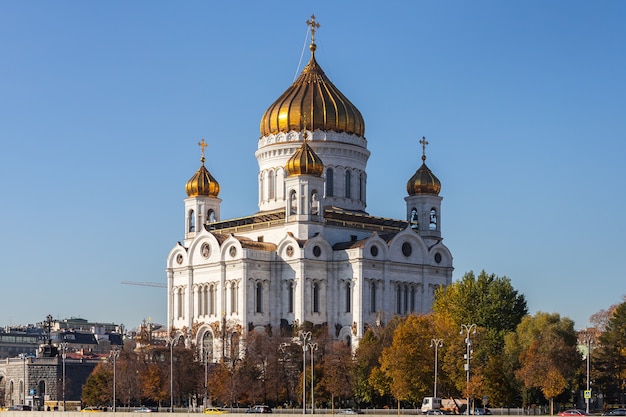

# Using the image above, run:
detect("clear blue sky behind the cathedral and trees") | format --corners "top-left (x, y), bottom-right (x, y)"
top-left (0, 0), bottom-right (626, 328)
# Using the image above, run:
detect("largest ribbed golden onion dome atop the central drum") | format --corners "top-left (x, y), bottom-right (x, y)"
top-left (261, 22), bottom-right (365, 137)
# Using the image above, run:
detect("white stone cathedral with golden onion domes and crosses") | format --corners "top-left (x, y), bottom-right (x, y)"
top-left (166, 16), bottom-right (453, 360)
